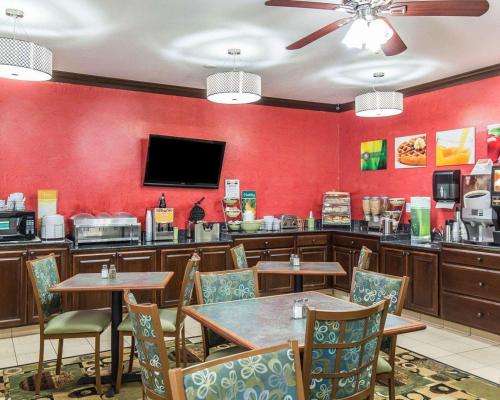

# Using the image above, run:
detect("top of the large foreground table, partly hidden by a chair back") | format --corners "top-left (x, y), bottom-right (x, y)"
top-left (183, 292), bottom-right (426, 349)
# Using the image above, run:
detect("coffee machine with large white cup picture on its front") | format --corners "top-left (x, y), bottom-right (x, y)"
top-left (462, 173), bottom-right (498, 244)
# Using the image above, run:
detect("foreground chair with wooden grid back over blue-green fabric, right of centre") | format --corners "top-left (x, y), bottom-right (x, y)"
top-left (303, 300), bottom-right (388, 400)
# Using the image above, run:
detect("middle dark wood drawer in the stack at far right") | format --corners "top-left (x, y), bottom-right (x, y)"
top-left (442, 264), bottom-right (500, 301)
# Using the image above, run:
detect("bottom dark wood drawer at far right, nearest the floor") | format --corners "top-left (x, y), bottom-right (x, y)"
top-left (442, 292), bottom-right (500, 333)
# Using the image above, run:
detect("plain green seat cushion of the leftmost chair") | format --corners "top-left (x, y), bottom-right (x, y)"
top-left (44, 310), bottom-right (111, 335)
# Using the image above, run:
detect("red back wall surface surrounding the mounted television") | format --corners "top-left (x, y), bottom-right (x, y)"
top-left (0, 80), bottom-right (339, 226)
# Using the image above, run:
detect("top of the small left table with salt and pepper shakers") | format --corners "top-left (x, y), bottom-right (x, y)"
top-left (50, 271), bottom-right (174, 292)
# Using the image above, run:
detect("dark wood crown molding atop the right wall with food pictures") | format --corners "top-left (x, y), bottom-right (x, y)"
top-left (339, 64), bottom-right (500, 112)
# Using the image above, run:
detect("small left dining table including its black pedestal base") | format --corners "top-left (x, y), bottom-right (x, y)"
top-left (49, 271), bottom-right (174, 397)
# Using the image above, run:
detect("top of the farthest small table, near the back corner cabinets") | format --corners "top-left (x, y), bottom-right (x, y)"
top-left (255, 261), bottom-right (347, 276)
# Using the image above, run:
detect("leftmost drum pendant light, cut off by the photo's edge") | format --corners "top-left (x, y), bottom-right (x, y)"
top-left (0, 8), bottom-right (52, 81)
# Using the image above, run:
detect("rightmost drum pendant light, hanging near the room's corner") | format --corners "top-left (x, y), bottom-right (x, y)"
top-left (354, 72), bottom-right (403, 118)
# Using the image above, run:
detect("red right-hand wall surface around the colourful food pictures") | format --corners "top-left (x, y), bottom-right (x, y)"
top-left (339, 73), bottom-right (500, 226)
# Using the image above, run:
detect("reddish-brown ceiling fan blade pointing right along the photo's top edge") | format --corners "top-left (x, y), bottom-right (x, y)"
top-left (389, 0), bottom-right (490, 17)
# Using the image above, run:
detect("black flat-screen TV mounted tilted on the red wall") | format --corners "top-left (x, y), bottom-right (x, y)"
top-left (144, 135), bottom-right (226, 189)
